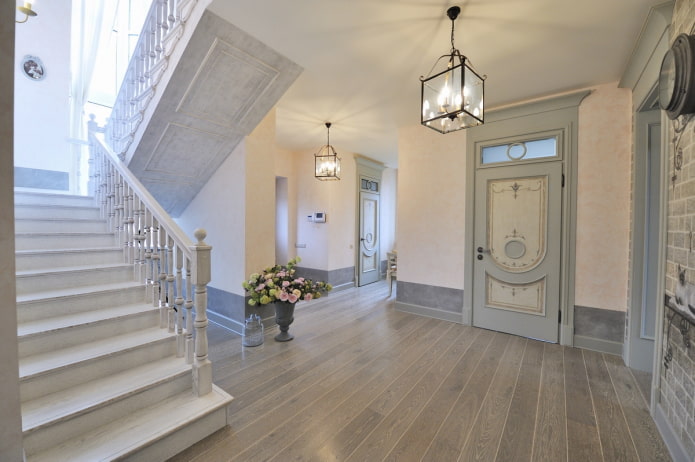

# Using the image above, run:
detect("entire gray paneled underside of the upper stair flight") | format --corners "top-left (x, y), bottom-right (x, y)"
top-left (128, 11), bottom-right (302, 217)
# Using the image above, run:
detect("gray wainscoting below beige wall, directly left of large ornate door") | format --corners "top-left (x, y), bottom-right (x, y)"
top-left (396, 281), bottom-right (463, 323)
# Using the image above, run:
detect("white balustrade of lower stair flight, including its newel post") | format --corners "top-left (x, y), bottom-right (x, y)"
top-left (89, 123), bottom-right (212, 396)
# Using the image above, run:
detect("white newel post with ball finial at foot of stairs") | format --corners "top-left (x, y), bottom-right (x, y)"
top-left (191, 228), bottom-right (212, 396)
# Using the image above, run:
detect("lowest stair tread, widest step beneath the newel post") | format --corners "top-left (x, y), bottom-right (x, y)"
top-left (28, 385), bottom-right (232, 462)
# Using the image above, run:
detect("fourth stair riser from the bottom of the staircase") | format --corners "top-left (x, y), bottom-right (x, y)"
top-left (19, 309), bottom-right (159, 358)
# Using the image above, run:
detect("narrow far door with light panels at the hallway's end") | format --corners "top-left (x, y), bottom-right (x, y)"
top-left (358, 191), bottom-right (380, 286)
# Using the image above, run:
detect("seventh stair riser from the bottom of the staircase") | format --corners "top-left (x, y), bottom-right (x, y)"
top-left (15, 249), bottom-right (123, 271)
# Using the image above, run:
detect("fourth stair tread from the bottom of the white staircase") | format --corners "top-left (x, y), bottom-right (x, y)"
top-left (17, 303), bottom-right (158, 337)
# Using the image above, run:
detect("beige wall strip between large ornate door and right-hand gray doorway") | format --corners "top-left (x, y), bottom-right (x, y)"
top-left (575, 82), bottom-right (632, 311)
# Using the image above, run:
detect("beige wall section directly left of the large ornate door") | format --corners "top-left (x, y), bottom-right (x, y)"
top-left (396, 125), bottom-right (466, 289)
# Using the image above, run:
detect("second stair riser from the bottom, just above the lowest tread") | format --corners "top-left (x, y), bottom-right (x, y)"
top-left (23, 372), bottom-right (193, 454)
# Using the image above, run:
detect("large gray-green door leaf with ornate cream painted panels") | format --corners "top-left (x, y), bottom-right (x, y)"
top-left (473, 161), bottom-right (562, 342)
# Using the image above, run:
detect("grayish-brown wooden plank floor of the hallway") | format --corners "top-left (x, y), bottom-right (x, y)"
top-left (167, 282), bottom-right (670, 462)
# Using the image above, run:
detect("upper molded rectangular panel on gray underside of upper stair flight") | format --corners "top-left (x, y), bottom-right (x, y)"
top-left (176, 38), bottom-right (280, 128)
